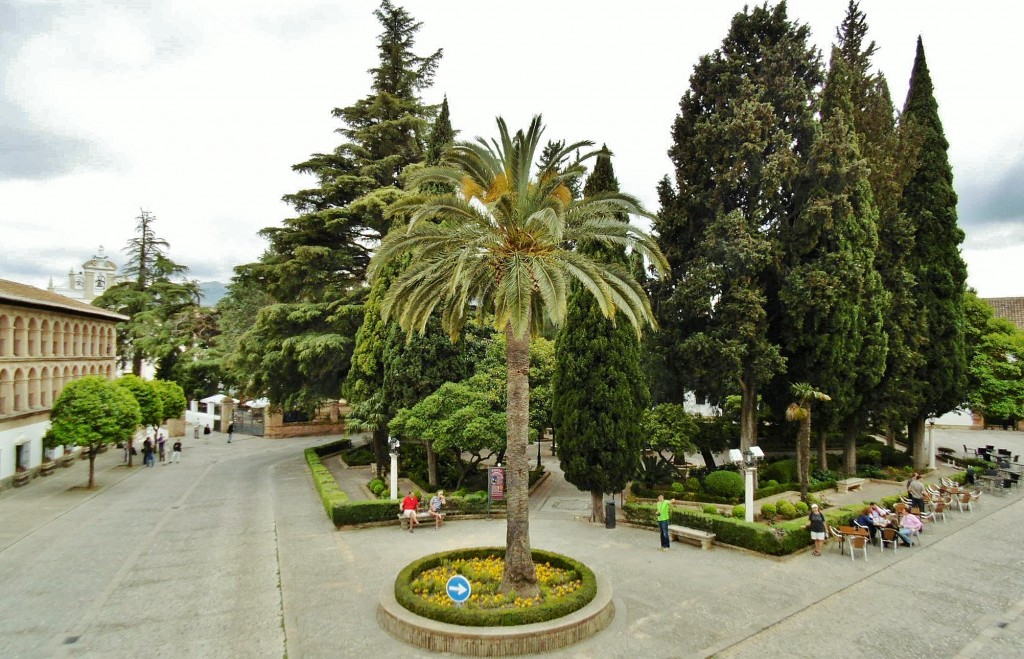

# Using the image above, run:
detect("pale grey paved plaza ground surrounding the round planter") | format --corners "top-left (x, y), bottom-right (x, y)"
top-left (0, 429), bottom-right (1024, 659)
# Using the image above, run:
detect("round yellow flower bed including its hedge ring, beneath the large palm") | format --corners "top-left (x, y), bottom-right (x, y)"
top-left (394, 547), bottom-right (597, 626)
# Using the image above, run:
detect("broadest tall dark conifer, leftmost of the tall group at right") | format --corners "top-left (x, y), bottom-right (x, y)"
top-left (654, 3), bottom-right (822, 449)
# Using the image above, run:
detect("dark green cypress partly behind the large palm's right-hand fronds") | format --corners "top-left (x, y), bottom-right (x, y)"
top-left (552, 149), bottom-right (650, 522)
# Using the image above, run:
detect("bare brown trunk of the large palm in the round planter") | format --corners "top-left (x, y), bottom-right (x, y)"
top-left (501, 323), bottom-right (540, 598)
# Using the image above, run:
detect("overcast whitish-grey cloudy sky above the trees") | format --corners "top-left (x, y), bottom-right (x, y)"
top-left (0, 0), bottom-right (1024, 297)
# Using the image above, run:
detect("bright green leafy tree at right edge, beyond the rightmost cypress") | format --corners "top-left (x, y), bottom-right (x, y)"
top-left (965, 292), bottom-right (1024, 424)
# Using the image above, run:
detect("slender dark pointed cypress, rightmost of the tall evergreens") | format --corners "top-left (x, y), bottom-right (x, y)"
top-left (900, 37), bottom-right (967, 468)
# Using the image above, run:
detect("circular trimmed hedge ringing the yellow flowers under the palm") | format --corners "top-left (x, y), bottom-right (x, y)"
top-left (394, 546), bottom-right (597, 627)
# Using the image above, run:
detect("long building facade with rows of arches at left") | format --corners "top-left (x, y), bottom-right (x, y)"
top-left (0, 279), bottom-right (128, 487)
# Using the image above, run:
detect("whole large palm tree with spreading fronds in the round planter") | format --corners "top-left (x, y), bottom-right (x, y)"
top-left (369, 116), bottom-right (668, 597)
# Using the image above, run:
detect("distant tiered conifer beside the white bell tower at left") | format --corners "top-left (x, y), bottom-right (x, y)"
top-left (92, 211), bottom-right (201, 376)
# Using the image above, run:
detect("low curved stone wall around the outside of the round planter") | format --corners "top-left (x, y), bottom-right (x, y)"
top-left (377, 574), bottom-right (615, 657)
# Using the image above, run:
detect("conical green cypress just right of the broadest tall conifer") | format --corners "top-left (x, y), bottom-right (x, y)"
top-left (778, 48), bottom-right (888, 474)
